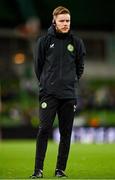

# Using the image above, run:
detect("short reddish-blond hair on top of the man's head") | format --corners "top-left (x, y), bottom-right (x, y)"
top-left (53, 6), bottom-right (70, 17)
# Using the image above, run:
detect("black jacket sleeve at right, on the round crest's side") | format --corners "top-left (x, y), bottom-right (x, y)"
top-left (76, 39), bottom-right (86, 80)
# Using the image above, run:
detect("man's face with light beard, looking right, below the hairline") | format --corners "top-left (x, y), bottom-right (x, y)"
top-left (55, 14), bottom-right (70, 33)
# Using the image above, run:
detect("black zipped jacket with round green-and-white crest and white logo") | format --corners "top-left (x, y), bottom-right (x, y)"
top-left (34, 26), bottom-right (85, 98)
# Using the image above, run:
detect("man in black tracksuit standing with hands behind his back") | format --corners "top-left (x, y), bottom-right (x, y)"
top-left (31, 6), bottom-right (85, 178)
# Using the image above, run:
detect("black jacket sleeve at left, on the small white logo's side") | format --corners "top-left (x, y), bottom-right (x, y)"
top-left (34, 37), bottom-right (45, 81)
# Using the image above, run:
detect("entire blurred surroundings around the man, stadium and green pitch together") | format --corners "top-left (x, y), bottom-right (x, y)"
top-left (0, 0), bottom-right (115, 179)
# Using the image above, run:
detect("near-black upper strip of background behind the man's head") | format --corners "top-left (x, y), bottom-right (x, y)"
top-left (0, 0), bottom-right (115, 31)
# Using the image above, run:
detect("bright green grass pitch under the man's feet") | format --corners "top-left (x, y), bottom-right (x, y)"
top-left (0, 140), bottom-right (115, 180)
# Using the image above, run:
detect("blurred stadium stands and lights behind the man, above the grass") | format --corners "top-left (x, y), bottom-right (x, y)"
top-left (0, 0), bottom-right (115, 143)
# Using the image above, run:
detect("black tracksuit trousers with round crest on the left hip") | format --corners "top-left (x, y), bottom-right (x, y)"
top-left (35, 95), bottom-right (75, 173)
